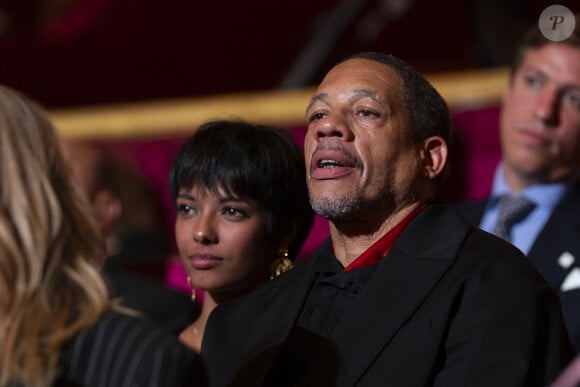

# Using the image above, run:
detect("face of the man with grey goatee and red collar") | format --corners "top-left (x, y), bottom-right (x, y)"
top-left (304, 59), bottom-right (419, 220)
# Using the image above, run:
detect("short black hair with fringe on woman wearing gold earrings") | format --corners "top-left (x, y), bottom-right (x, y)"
top-left (169, 120), bottom-right (314, 259)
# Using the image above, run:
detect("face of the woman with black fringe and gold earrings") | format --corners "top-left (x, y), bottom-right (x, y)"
top-left (175, 186), bottom-right (281, 300)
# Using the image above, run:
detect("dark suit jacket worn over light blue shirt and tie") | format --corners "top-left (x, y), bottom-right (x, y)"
top-left (456, 184), bottom-right (580, 351)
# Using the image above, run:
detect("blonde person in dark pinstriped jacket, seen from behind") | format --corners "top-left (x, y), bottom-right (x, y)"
top-left (0, 87), bottom-right (204, 387)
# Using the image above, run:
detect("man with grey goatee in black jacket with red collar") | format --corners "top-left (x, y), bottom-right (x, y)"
top-left (202, 53), bottom-right (572, 387)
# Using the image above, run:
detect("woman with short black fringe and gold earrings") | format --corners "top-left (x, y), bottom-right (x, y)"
top-left (169, 121), bottom-right (314, 351)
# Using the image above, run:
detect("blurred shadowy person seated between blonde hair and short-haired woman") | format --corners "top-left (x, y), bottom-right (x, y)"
top-left (64, 139), bottom-right (200, 335)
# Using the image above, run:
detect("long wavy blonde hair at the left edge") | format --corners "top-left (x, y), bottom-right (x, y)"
top-left (0, 86), bottom-right (111, 386)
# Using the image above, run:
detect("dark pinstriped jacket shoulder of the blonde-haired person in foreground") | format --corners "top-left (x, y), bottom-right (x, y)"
top-left (56, 311), bottom-right (205, 386)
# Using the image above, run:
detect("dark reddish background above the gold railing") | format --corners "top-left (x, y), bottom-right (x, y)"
top-left (0, 0), bottom-right (579, 108)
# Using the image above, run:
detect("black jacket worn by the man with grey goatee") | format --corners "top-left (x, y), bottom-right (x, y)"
top-left (202, 205), bottom-right (572, 387)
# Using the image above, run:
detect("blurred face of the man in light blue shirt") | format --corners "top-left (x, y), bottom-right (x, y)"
top-left (500, 43), bottom-right (580, 190)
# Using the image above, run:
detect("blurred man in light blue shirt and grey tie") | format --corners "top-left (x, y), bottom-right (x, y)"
top-left (457, 16), bottom-right (580, 352)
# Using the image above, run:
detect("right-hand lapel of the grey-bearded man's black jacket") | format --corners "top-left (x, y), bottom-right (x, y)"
top-left (313, 205), bottom-right (469, 386)
